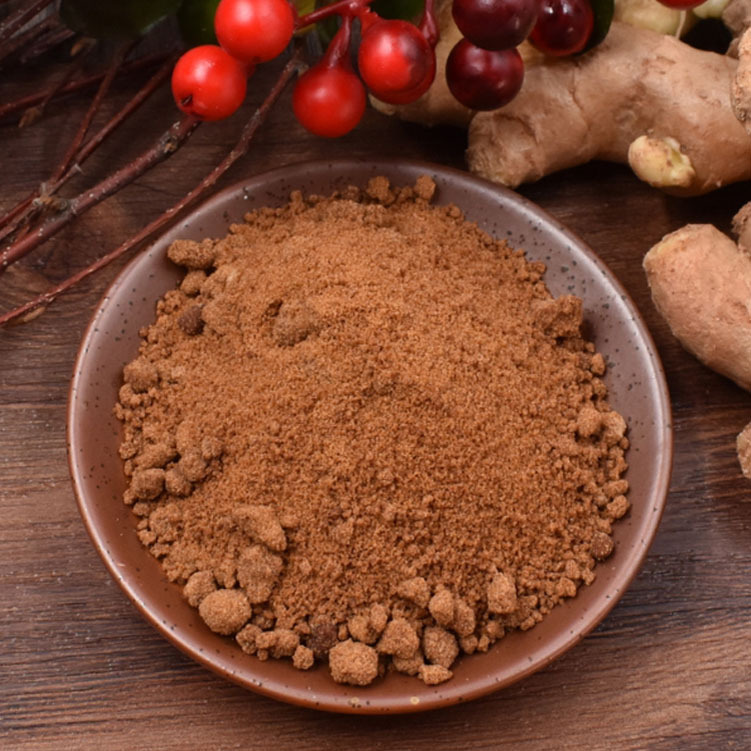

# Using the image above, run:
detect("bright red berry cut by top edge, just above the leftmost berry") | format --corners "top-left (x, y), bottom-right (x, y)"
top-left (214, 0), bottom-right (295, 63)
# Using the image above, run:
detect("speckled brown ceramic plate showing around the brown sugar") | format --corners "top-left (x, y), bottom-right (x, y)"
top-left (68, 161), bottom-right (672, 714)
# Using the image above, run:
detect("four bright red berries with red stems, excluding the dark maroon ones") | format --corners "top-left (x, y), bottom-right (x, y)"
top-left (172, 0), bottom-right (438, 137)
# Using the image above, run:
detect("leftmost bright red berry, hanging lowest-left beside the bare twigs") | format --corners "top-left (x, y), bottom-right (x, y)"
top-left (172, 44), bottom-right (248, 120)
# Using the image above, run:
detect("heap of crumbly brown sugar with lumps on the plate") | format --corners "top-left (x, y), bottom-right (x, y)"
top-left (116, 178), bottom-right (629, 685)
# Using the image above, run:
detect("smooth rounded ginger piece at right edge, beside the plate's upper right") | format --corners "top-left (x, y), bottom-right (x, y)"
top-left (644, 224), bottom-right (751, 391)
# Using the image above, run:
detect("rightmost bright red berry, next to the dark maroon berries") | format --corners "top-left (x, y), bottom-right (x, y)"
top-left (357, 20), bottom-right (435, 104)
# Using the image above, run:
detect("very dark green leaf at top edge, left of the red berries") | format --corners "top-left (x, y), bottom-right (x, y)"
top-left (60, 0), bottom-right (180, 39)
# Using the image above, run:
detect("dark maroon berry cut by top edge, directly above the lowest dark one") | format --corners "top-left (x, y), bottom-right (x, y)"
top-left (451, 0), bottom-right (538, 50)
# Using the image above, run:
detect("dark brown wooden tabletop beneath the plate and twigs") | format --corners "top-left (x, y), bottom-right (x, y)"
top-left (0, 48), bottom-right (751, 751)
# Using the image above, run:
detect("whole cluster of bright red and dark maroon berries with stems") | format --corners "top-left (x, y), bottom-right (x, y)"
top-left (172, 0), bottom-right (612, 138)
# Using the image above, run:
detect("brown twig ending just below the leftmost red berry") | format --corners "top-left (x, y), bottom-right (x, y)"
top-left (0, 117), bottom-right (199, 274)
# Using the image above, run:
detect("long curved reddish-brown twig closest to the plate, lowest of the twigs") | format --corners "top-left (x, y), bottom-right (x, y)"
top-left (0, 48), bottom-right (302, 327)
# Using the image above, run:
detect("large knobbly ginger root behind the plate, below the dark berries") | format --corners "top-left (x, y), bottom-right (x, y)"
top-left (467, 23), bottom-right (751, 195)
